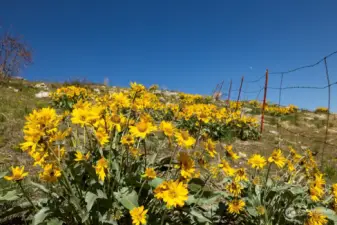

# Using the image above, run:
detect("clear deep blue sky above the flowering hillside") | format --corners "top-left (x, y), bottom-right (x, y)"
top-left (0, 0), bottom-right (337, 110)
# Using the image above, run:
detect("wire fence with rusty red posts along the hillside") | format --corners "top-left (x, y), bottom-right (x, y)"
top-left (214, 51), bottom-right (337, 165)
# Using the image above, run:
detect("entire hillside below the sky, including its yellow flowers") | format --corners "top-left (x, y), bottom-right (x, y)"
top-left (0, 80), bottom-right (337, 225)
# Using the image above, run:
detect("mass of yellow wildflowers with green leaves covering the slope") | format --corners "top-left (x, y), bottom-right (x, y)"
top-left (4, 83), bottom-right (337, 225)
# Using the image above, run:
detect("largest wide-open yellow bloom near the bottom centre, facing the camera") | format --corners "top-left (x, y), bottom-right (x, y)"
top-left (154, 180), bottom-right (188, 208)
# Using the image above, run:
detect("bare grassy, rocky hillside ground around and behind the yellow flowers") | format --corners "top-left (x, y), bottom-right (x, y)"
top-left (0, 80), bottom-right (337, 180)
